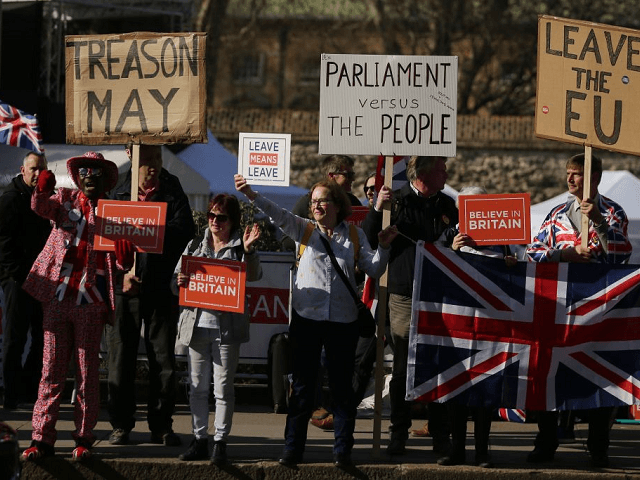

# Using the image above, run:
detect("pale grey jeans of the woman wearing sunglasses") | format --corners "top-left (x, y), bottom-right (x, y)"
top-left (188, 327), bottom-right (240, 442)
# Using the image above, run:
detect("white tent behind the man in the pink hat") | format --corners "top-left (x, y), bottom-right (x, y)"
top-left (0, 144), bottom-right (209, 210)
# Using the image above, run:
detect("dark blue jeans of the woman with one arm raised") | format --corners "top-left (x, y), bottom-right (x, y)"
top-left (285, 311), bottom-right (358, 456)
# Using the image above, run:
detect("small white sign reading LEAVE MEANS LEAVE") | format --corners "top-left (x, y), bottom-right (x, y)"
top-left (238, 133), bottom-right (291, 187)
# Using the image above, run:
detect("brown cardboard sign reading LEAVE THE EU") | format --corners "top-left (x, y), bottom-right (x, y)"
top-left (535, 16), bottom-right (640, 155)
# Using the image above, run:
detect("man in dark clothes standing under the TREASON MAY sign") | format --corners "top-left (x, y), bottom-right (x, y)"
top-left (108, 145), bottom-right (195, 446)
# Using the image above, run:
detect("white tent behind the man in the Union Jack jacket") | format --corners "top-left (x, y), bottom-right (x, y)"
top-left (531, 170), bottom-right (640, 265)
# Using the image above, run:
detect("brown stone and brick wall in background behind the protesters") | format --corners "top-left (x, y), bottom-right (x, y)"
top-left (209, 109), bottom-right (640, 204)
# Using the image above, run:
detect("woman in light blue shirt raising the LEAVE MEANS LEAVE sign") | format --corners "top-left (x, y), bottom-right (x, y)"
top-left (235, 175), bottom-right (397, 468)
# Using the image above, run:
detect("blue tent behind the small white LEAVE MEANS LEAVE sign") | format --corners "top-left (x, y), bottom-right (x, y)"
top-left (178, 131), bottom-right (308, 210)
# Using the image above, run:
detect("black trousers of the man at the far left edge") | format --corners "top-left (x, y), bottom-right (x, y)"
top-left (2, 278), bottom-right (43, 405)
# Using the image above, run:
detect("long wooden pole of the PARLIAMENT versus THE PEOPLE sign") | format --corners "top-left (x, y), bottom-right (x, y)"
top-left (373, 157), bottom-right (393, 457)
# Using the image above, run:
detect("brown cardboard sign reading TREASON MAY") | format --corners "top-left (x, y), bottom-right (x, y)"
top-left (65, 32), bottom-right (207, 145)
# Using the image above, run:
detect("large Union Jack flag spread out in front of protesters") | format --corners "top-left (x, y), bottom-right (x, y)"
top-left (407, 242), bottom-right (640, 410)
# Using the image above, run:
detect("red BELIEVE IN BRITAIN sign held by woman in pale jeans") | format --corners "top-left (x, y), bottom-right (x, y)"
top-left (179, 255), bottom-right (247, 313)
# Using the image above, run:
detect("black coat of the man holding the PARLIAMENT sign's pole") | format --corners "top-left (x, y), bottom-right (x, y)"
top-left (362, 183), bottom-right (458, 297)
